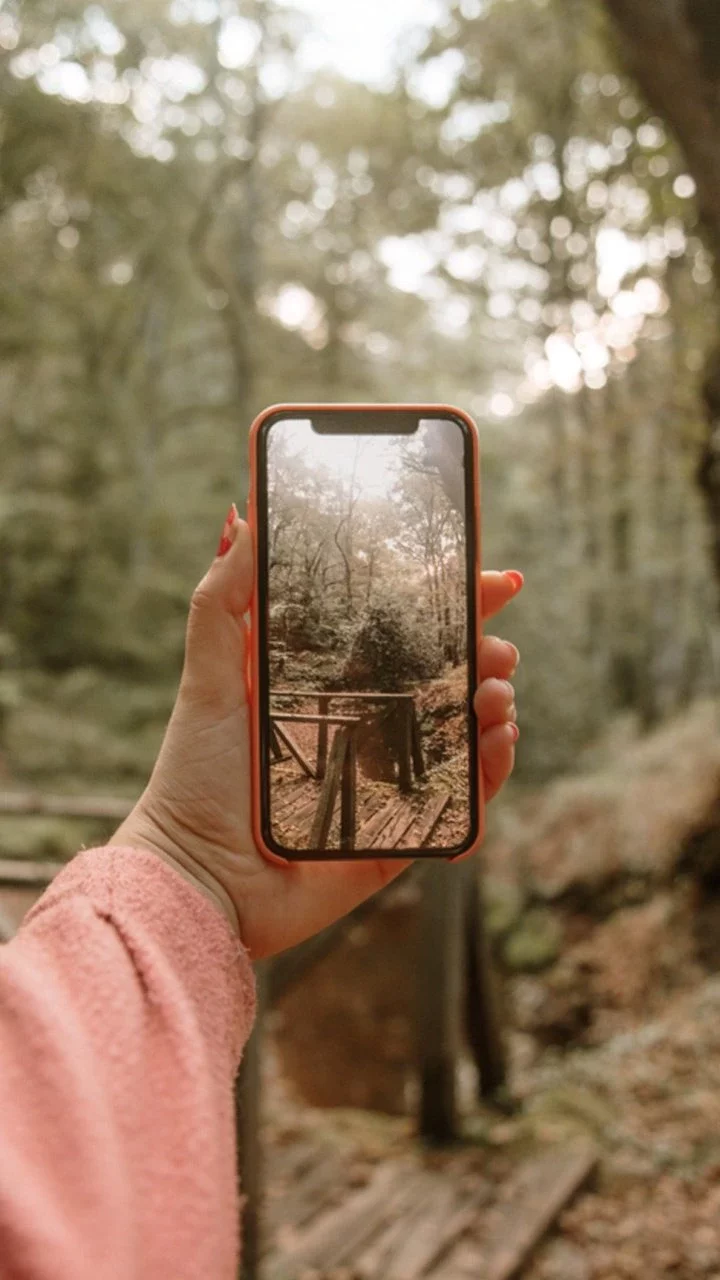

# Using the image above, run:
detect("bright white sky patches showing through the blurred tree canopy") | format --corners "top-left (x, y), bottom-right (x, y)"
top-left (11, 0), bottom-right (693, 417)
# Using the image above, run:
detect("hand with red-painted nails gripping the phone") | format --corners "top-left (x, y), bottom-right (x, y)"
top-left (113, 509), bottom-right (523, 960)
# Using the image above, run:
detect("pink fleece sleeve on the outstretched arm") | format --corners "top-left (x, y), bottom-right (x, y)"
top-left (0, 849), bottom-right (255, 1280)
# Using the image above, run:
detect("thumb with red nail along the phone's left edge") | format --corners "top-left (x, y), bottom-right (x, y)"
top-left (182, 506), bottom-right (254, 713)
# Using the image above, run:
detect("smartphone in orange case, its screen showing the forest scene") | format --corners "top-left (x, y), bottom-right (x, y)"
top-left (249, 404), bottom-right (483, 861)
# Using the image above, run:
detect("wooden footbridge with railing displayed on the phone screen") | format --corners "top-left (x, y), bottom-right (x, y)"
top-left (270, 689), bottom-right (451, 852)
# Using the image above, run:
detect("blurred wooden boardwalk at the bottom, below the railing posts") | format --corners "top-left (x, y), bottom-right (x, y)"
top-left (260, 1139), bottom-right (597, 1280)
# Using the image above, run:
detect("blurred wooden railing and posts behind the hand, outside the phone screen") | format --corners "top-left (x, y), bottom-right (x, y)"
top-left (0, 788), bottom-right (506, 1280)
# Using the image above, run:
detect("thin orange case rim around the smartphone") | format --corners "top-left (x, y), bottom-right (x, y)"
top-left (247, 402), bottom-right (486, 864)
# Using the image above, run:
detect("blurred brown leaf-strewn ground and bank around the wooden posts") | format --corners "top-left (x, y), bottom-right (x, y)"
top-left (268, 707), bottom-right (720, 1280)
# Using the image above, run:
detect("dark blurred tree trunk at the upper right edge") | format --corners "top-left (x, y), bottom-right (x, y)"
top-left (605, 0), bottom-right (720, 582)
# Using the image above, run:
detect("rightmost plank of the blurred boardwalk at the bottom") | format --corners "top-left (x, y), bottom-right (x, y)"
top-left (478, 1142), bottom-right (598, 1280)
